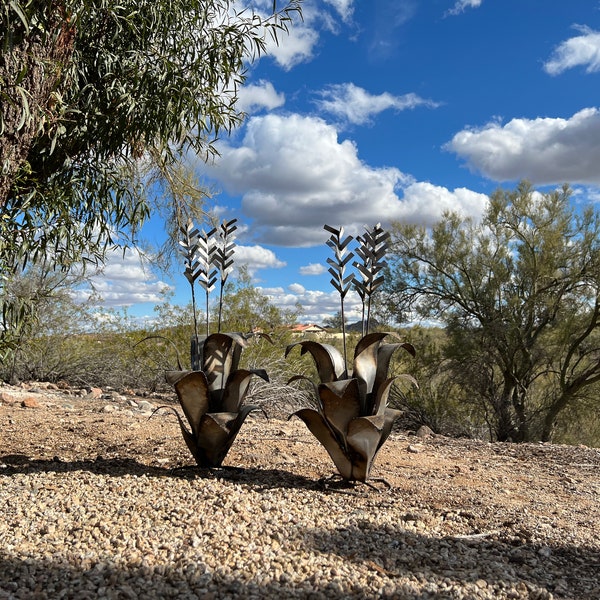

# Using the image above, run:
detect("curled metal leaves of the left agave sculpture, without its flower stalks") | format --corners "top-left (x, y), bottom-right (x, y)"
top-left (161, 333), bottom-right (269, 468)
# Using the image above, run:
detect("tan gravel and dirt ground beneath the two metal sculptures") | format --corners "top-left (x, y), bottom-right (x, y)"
top-left (0, 386), bottom-right (600, 600)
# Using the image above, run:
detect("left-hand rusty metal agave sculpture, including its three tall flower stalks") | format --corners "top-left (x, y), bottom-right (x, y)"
top-left (160, 219), bottom-right (272, 468)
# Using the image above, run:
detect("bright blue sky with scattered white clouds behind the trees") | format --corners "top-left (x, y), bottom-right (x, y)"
top-left (86, 0), bottom-right (600, 323)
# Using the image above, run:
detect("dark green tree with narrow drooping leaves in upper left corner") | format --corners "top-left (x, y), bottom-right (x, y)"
top-left (0, 0), bottom-right (301, 269)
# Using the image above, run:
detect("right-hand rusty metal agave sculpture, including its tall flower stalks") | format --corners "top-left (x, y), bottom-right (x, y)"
top-left (285, 225), bottom-right (417, 483)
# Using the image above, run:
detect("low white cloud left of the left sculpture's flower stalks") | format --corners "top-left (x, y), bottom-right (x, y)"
top-left (77, 249), bottom-right (170, 307)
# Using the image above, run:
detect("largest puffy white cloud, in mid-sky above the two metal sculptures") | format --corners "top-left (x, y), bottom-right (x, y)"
top-left (199, 114), bottom-right (487, 247)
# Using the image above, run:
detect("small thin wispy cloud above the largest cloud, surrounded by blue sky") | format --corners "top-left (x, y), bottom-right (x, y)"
top-left (317, 83), bottom-right (438, 125)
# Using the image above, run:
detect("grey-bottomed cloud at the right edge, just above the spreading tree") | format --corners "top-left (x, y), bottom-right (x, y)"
top-left (446, 108), bottom-right (600, 184)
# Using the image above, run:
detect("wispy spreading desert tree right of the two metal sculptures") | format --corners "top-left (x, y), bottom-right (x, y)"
top-left (387, 183), bottom-right (600, 441)
